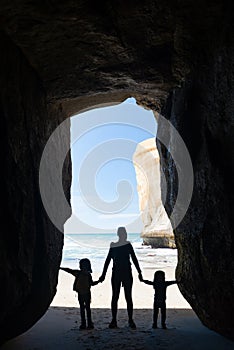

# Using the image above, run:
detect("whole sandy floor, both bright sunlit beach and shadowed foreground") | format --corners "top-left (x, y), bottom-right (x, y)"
top-left (1, 268), bottom-right (234, 350)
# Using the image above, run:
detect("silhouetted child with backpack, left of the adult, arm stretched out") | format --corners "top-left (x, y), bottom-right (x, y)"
top-left (60, 259), bottom-right (99, 329)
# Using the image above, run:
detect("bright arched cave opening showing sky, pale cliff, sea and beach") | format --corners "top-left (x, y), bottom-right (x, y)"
top-left (52, 98), bottom-right (190, 308)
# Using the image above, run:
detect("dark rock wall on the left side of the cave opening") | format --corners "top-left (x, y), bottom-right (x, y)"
top-left (0, 32), bottom-right (70, 342)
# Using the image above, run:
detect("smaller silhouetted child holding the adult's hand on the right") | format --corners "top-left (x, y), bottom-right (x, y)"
top-left (140, 270), bottom-right (177, 329)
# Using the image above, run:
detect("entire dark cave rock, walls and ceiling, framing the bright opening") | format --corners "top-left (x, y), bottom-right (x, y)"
top-left (0, 0), bottom-right (234, 341)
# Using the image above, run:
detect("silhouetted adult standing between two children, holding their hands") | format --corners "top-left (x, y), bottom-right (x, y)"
top-left (99, 227), bottom-right (142, 329)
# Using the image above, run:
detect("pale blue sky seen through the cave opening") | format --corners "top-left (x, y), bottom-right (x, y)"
top-left (65, 98), bottom-right (157, 233)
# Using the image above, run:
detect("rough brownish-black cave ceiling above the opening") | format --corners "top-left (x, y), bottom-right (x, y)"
top-left (0, 0), bottom-right (176, 109)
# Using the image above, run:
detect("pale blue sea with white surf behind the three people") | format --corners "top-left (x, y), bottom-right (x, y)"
top-left (62, 233), bottom-right (177, 272)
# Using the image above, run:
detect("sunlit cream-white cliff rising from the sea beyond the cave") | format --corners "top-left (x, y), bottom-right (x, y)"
top-left (133, 138), bottom-right (175, 248)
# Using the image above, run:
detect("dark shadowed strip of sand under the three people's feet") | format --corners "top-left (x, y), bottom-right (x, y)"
top-left (1, 307), bottom-right (234, 350)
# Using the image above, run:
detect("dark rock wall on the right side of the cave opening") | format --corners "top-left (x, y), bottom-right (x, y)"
top-left (158, 18), bottom-right (234, 337)
